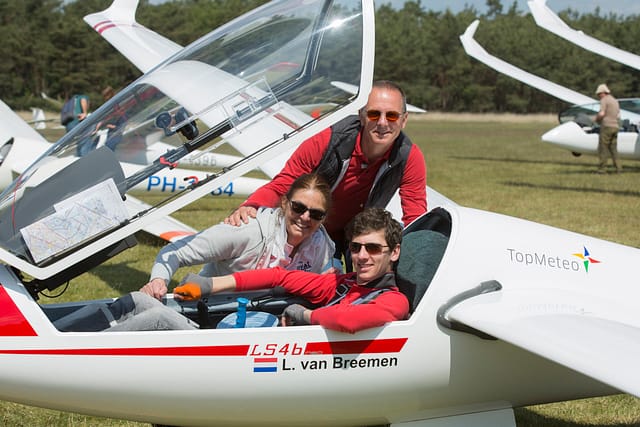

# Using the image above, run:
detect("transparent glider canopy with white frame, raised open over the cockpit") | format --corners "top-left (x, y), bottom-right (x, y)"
top-left (0, 0), bottom-right (373, 281)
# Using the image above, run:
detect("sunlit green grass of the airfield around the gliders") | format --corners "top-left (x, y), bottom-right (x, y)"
top-left (0, 114), bottom-right (640, 427)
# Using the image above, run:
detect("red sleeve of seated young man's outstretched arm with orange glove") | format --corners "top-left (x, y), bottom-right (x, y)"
top-left (233, 267), bottom-right (348, 304)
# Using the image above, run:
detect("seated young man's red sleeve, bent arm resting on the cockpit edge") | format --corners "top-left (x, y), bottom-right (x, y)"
top-left (311, 291), bottom-right (409, 334)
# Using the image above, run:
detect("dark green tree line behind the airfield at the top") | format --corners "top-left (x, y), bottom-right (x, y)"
top-left (0, 0), bottom-right (640, 114)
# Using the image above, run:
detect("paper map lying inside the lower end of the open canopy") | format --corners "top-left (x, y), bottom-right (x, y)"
top-left (20, 178), bottom-right (128, 262)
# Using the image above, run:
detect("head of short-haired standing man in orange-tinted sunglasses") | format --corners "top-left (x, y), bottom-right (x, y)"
top-left (360, 86), bottom-right (408, 161)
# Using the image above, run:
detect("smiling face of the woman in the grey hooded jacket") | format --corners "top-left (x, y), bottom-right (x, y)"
top-left (282, 189), bottom-right (327, 247)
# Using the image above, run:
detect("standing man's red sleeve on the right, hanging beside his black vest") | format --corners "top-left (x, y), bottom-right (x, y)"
top-left (400, 144), bottom-right (427, 227)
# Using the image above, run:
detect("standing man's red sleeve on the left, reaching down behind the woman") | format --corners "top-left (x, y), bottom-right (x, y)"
top-left (242, 128), bottom-right (331, 208)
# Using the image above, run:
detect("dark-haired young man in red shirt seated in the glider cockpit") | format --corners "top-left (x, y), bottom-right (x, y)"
top-left (174, 208), bottom-right (409, 333)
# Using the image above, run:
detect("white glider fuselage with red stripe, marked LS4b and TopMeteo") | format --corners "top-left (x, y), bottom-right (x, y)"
top-left (0, 202), bottom-right (640, 425)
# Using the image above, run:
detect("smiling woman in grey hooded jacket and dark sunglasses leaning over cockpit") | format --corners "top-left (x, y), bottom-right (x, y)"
top-left (140, 174), bottom-right (335, 299)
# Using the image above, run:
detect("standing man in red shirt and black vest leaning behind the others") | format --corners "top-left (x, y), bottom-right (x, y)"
top-left (224, 80), bottom-right (427, 262)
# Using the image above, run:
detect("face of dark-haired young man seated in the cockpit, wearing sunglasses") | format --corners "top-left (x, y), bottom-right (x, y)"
top-left (350, 230), bottom-right (400, 285)
